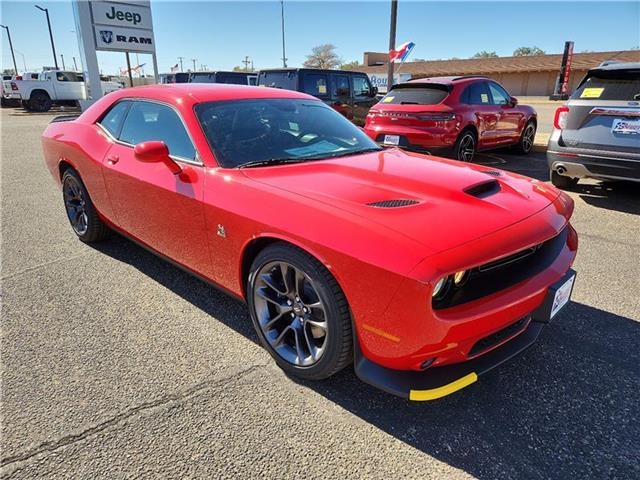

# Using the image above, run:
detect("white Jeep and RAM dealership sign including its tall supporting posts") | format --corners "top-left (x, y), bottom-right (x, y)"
top-left (73, 0), bottom-right (158, 109)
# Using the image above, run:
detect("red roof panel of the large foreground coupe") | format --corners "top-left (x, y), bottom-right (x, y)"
top-left (109, 83), bottom-right (317, 104)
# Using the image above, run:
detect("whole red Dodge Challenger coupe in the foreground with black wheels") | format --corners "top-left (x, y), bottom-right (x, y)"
top-left (42, 84), bottom-right (578, 400)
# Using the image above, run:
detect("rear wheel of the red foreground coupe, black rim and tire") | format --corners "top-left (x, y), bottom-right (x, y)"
top-left (62, 168), bottom-right (109, 243)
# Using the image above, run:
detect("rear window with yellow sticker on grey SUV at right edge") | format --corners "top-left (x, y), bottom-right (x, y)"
top-left (571, 70), bottom-right (640, 101)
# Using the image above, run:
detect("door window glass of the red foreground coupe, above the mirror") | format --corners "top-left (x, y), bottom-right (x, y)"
top-left (120, 101), bottom-right (196, 160)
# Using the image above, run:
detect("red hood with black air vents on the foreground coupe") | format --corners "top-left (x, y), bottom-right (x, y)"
top-left (242, 149), bottom-right (559, 254)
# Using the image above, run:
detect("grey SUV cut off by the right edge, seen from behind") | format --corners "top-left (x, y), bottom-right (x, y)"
top-left (547, 63), bottom-right (640, 188)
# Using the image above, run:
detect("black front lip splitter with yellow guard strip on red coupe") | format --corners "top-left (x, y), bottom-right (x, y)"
top-left (354, 269), bottom-right (575, 401)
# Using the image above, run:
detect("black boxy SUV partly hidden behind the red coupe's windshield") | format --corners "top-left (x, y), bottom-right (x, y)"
top-left (258, 68), bottom-right (378, 126)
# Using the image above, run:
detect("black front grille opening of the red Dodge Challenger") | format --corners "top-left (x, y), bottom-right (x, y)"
top-left (433, 228), bottom-right (569, 310)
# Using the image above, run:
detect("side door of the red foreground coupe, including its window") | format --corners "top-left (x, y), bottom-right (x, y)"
top-left (102, 100), bottom-right (211, 274)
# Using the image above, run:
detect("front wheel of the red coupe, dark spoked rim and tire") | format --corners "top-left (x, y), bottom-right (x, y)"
top-left (247, 243), bottom-right (352, 380)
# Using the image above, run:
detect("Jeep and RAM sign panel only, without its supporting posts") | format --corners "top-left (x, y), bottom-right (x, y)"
top-left (90, 1), bottom-right (156, 53)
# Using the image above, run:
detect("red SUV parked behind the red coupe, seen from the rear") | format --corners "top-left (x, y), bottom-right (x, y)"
top-left (364, 76), bottom-right (537, 162)
